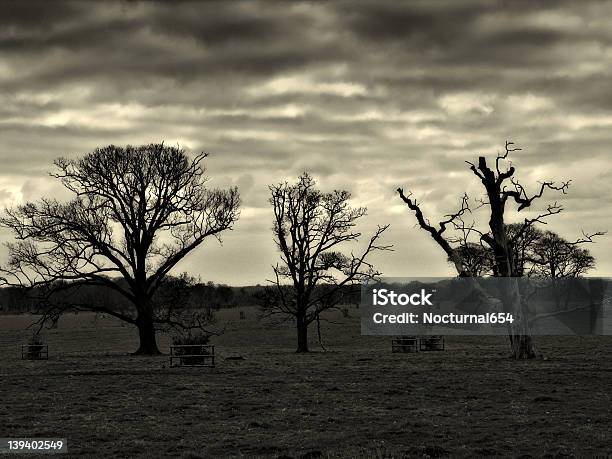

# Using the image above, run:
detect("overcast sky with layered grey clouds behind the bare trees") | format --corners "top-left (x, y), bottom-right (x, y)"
top-left (0, 0), bottom-right (612, 285)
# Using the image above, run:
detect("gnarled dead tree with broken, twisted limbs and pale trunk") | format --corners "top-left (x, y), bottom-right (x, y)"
top-left (397, 142), bottom-right (601, 359)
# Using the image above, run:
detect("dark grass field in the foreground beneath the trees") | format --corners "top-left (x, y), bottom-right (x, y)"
top-left (0, 309), bottom-right (612, 458)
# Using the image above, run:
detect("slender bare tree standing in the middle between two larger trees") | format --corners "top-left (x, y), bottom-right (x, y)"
top-left (264, 173), bottom-right (391, 352)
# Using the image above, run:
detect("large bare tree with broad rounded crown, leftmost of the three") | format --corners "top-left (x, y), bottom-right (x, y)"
top-left (0, 144), bottom-right (239, 354)
